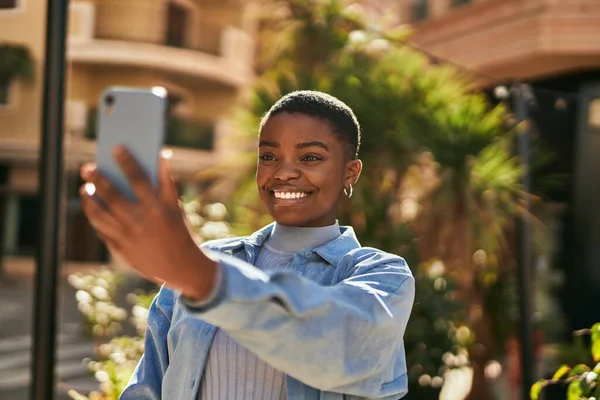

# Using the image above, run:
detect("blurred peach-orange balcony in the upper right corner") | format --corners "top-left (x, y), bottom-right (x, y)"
top-left (410, 0), bottom-right (600, 81)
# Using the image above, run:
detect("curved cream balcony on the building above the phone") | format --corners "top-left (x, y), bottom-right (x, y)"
top-left (67, 0), bottom-right (255, 88)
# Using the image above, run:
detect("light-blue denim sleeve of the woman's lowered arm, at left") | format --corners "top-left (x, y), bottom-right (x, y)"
top-left (119, 286), bottom-right (175, 400)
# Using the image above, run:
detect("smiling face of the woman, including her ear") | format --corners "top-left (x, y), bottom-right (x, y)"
top-left (256, 112), bottom-right (362, 227)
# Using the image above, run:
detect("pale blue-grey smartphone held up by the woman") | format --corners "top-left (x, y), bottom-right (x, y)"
top-left (96, 87), bottom-right (167, 201)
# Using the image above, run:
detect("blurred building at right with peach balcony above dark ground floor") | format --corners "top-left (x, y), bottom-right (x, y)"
top-left (398, 0), bottom-right (600, 328)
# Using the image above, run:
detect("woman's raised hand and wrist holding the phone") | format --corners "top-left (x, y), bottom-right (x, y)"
top-left (80, 147), bottom-right (218, 300)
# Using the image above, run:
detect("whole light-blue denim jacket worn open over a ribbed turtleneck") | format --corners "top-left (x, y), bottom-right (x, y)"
top-left (120, 225), bottom-right (415, 400)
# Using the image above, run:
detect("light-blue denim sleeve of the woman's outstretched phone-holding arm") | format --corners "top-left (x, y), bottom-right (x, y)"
top-left (180, 248), bottom-right (415, 398)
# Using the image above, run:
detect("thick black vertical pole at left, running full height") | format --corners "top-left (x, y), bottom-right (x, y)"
top-left (31, 0), bottom-right (68, 400)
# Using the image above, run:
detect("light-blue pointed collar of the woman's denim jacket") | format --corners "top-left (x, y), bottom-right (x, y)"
top-left (220, 223), bottom-right (360, 266)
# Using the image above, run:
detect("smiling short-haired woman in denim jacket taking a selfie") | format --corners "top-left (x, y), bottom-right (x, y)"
top-left (81, 91), bottom-right (415, 400)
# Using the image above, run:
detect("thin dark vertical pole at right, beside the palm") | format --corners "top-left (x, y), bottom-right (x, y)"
top-left (512, 84), bottom-right (535, 400)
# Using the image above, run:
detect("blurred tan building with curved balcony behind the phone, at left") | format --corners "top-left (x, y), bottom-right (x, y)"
top-left (0, 0), bottom-right (255, 270)
